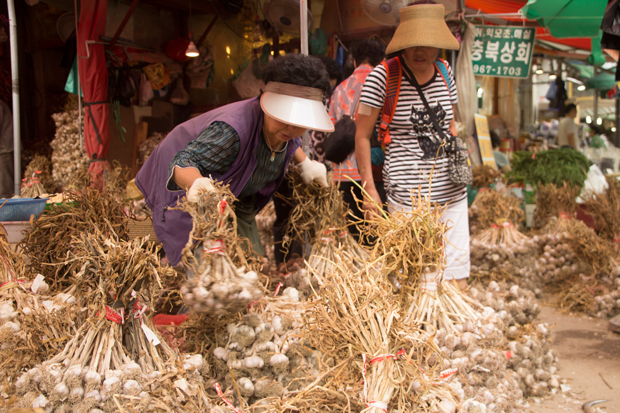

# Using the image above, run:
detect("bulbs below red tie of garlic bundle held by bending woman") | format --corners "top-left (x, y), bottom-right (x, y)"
top-left (181, 241), bottom-right (262, 314)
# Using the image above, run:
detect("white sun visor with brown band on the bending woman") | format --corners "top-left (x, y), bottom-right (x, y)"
top-left (260, 82), bottom-right (334, 132)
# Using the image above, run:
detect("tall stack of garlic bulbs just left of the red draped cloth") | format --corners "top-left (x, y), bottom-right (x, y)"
top-left (50, 110), bottom-right (88, 187)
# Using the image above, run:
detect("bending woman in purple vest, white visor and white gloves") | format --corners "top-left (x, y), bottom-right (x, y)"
top-left (136, 55), bottom-right (334, 265)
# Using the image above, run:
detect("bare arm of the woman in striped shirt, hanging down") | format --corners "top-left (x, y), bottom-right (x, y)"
top-left (355, 104), bottom-right (381, 213)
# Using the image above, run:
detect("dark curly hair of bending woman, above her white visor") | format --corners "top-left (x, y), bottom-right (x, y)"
top-left (263, 54), bottom-right (332, 97)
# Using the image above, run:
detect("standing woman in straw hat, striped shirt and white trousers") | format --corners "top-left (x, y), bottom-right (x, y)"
top-left (355, 1), bottom-right (469, 287)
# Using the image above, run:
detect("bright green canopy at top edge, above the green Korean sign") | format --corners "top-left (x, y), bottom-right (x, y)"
top-left (521, 0), bottom-right (607, 39)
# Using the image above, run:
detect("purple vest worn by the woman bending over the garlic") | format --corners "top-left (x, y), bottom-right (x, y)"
top-left (136, 98), bottom-right (301, 265)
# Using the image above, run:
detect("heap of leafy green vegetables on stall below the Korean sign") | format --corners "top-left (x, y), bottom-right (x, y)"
top-left (506, 148), bottom-right (590, 188)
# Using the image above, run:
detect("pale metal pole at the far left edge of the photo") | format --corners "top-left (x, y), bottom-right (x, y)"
top-left (6, 0), bottom-right (22, 196)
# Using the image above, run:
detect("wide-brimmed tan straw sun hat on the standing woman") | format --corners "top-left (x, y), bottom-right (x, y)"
top-left (385, 4), bottom-right (460, 54)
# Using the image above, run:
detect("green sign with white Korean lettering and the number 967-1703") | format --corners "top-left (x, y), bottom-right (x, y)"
top-left (471, 26), bottom-right (536, 78)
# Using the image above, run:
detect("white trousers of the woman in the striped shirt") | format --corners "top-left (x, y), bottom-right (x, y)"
top-left (388, 198), bottom-right (470, 280)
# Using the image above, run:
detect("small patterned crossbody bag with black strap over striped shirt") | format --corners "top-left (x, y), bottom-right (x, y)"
top-left (403, 65), bottom-right (474, 185)
